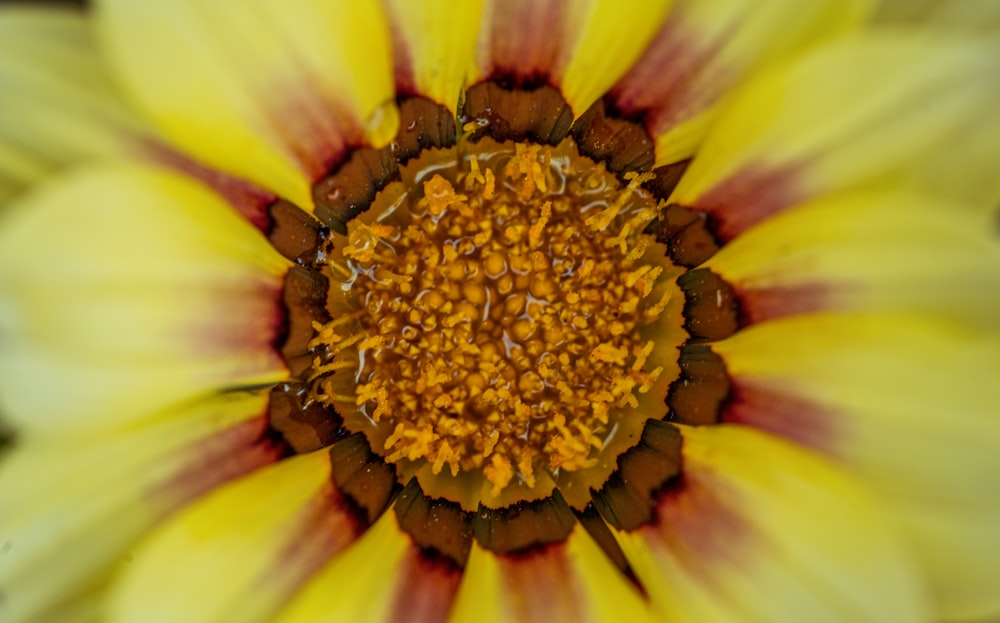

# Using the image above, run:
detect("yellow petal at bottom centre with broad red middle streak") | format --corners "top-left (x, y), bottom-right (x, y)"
top-left (448, 525), bottom-right (653, 623)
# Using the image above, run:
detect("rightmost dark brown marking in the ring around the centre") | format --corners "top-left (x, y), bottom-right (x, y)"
top-left (677, 268), bottom-right (741, 340)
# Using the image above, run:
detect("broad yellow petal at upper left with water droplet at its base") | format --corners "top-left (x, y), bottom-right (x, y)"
top-left (97, 0), bottom-right (398, 207)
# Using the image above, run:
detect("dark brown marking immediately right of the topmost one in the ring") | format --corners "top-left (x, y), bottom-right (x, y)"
top-left (572, 99), bottom-right (656, 173)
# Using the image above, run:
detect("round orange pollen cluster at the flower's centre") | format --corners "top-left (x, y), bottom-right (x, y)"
top-left (310, 144), bottom-right (670, 494)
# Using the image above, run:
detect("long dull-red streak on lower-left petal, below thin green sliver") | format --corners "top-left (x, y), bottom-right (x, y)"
top-left (150, 413), bottom-right (284, 511)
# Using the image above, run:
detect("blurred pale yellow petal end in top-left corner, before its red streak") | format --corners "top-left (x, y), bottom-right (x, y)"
top-left (0, 5), bottom-right (142, 198)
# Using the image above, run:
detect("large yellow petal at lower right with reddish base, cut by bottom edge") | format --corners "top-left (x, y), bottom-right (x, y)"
top-left (619, 425), bottom-right (928, 622)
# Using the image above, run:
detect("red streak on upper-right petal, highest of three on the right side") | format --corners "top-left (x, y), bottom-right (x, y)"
top-left (685, 167), bottom-right (807, 241)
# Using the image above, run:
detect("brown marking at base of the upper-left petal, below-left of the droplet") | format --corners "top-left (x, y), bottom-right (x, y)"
top-left (313, 146), bottom-right (399, 234)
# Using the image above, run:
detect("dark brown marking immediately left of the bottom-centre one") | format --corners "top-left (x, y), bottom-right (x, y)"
top-left (393, 478), bottom-right (473, 569)
